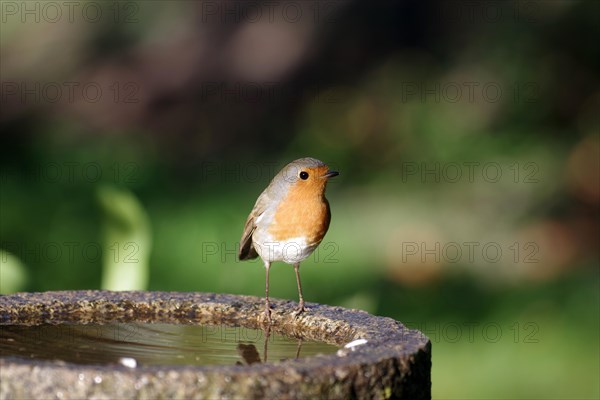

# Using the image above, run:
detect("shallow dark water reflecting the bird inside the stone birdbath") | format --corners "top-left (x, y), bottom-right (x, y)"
top-left (0, 323), bottom-right (338, 368)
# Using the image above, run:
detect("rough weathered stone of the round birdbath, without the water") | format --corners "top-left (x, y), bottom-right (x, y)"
top-left (0, 291), bottom-right (431, 399)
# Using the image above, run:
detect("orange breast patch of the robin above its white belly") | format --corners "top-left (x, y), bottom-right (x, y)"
top-left (269, 182), bottom-right (331, 244)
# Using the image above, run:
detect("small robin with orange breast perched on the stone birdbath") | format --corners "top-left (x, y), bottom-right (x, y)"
top-left (239, 157), bottom-right (338, 321)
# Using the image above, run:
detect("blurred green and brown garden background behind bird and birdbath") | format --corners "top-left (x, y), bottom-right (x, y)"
top-left (0, 0), bottom-right (600, 399)
